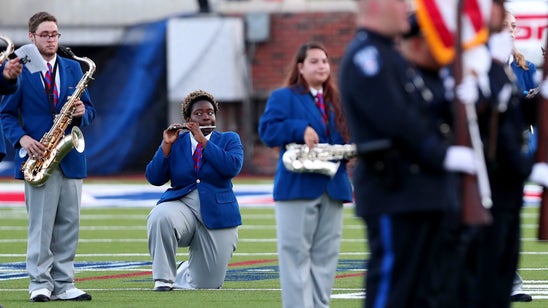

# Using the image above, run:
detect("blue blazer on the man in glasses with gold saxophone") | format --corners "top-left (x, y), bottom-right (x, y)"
top-left (0, 56), bottom-right (96, 179)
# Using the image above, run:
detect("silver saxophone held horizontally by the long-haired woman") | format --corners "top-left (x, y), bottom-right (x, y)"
top-left (282, 143), bottom-right (357, 177)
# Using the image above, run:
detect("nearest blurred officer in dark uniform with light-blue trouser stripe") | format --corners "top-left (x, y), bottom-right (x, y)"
top-left (340, 0), bottom-right (476, 307)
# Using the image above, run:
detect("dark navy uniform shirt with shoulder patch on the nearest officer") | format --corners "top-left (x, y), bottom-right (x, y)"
top-left (339, 29), bottom-right (456, 215)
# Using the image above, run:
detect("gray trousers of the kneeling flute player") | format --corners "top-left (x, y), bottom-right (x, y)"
top-left (147, 190), bottom-right (238, 289)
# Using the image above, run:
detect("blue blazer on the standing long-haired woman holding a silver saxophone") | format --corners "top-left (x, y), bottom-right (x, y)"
top-left (259, 87), bottom-right (352, 202)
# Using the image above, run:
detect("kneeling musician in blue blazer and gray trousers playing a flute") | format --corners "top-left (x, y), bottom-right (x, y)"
top-left (146, 90), bottom-right (244, 291)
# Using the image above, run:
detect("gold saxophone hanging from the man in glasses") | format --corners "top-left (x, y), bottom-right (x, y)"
top-left (21, 47), bottom-right (95, 186)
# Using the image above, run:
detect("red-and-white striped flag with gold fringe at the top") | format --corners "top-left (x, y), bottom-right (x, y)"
top-left (415, 0), bottom-right (492, 65)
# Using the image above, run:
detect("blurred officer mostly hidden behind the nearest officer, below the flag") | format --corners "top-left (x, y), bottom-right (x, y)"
top-left (399, 13), bottom-right (461, 307)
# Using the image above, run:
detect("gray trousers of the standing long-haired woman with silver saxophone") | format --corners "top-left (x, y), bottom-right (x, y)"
top-left (275, 193), bottom-right (343, 308)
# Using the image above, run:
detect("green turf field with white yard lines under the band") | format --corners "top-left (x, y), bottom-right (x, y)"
top-left (0, 182), bottom-right (548, 308)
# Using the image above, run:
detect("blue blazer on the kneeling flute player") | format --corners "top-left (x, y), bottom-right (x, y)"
top-left (146, 131), bottom-right (244, 229)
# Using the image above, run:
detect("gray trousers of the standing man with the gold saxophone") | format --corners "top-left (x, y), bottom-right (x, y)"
top-left (25, 168), bottom-right (82, 294)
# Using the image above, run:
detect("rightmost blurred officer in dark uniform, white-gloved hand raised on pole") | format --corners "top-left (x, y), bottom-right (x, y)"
top-left (463, 0), bottom-right (548, 307)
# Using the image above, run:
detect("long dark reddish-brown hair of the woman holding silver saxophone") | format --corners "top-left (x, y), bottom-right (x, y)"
top-left (284, 42), bottom-right (350, 142)
